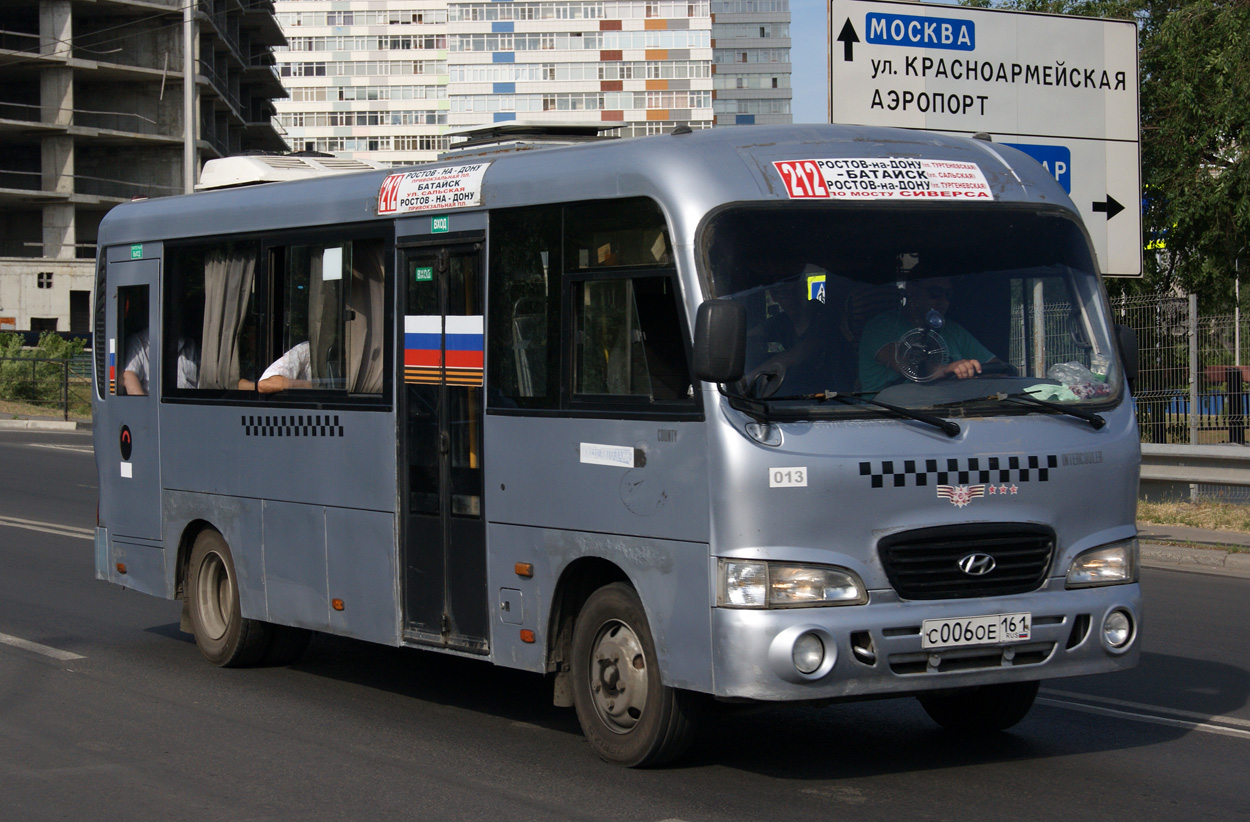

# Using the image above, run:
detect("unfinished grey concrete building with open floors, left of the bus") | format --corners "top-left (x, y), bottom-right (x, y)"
top-left (0, 0), bottom-right (286, 331)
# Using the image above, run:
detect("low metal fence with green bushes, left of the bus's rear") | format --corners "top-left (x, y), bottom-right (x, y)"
top-left (0, 354), bottom-right (91, 420)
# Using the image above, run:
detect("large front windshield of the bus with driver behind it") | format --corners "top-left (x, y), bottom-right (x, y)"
top-left (701, 204), bottom-right (1121, 417)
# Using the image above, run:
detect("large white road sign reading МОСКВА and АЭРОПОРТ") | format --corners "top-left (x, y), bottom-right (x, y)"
top-left (829, 0), bottom-right (1141, 276)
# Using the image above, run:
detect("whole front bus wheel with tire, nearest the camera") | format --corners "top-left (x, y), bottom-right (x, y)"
top-left (573, 582), bottom-right (700, 768)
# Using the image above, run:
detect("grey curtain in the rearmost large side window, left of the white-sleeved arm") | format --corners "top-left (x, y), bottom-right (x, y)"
top-left (199, 244), bottom-right (256, 389)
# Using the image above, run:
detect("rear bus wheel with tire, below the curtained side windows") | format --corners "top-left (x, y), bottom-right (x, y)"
top-left (186, 530), bottom-right (274, 668)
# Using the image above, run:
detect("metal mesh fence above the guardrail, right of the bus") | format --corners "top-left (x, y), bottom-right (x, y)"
top-left (1111, 295), bottom-right (1250, 445)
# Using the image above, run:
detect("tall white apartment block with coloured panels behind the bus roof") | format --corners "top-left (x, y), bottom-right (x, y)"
top-left (276, 0), bottom-right (791, 165)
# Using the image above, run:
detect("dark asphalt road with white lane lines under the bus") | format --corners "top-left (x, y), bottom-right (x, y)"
top-left (0, 431), bottom-right (1250, 822)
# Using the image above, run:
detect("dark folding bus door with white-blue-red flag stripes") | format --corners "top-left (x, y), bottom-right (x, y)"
top-left (398, 244), bottom-right (489, 653)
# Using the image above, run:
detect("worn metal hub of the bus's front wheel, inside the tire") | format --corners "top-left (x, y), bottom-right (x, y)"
top-left (589, 620), bottom-right (648, 733)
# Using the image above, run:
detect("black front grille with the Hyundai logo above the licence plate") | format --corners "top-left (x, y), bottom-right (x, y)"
top-left (878, 522), bottom-right (1055, 600)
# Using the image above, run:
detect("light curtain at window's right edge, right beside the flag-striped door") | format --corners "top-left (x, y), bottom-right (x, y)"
top-left (346, 240), bottom-right (386, 394)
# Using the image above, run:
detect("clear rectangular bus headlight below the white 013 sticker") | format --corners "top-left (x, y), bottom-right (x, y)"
top-left (716, 560), bottom-right (868, 608)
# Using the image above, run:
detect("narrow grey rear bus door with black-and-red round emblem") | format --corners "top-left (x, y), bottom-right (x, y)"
top-left (96, 252), bottom-right (161, 541)
